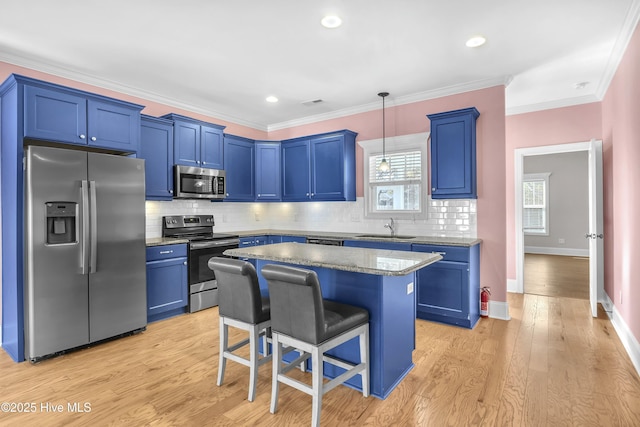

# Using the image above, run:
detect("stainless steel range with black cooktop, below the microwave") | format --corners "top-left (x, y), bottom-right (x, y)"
top-left (162, 215), bottom-right (240, 313)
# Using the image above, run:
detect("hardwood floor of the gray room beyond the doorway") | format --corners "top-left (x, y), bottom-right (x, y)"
top-left (524, 254), bottom-right (589, 299)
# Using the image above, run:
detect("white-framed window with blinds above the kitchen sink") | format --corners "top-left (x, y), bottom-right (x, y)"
top-left (359, 134), bottom-right (428, 218)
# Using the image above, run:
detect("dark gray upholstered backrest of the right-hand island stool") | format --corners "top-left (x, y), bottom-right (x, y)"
top-left (262, 264), bottom-right (325, 343)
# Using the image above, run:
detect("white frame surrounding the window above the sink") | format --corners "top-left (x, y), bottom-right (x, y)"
top-left (358, 132), bottom-right (430, 220)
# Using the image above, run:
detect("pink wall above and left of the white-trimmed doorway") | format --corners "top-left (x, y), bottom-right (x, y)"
top-left (505, 102), bottom-right (602, 280)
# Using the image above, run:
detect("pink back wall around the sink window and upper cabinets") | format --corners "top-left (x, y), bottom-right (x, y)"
top-left (269, 86), bottom-right (507, 302)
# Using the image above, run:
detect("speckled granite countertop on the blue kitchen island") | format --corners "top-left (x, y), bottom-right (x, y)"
top-left (224, 243), bottom-right (442, 276)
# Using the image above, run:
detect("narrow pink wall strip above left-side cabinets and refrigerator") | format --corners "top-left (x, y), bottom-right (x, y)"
top-left (0, 61), bottom-right (267, 139)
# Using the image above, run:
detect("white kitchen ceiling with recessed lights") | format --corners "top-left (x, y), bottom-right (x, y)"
top-left (0, 0), bottom-right (640, 130)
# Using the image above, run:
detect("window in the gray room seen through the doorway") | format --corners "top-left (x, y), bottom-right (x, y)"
top-left (522, 173), bottom-right (550, 235)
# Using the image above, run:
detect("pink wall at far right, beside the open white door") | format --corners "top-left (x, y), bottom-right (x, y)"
top-left (602, 21), bottom-right (640, 340)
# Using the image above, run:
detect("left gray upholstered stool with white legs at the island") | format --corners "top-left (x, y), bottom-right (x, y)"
top-left (208, 257), bottom-right (271, 402)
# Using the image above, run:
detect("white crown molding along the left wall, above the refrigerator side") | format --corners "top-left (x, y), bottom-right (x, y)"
top-left (0, 52), bottom-right (267, 132)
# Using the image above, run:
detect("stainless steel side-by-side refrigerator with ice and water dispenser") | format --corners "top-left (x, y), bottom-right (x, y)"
top-left (24, 146), bottom-right (147, 361)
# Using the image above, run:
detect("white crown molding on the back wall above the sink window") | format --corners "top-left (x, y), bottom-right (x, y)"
top-left (267, 76), bottom-right (513, 132)
